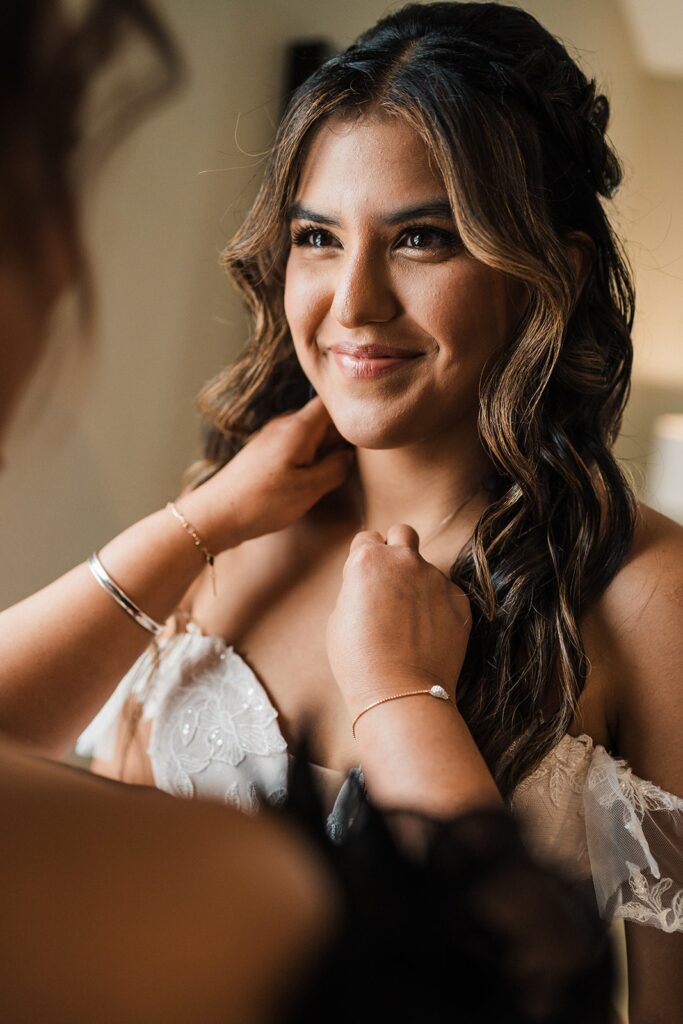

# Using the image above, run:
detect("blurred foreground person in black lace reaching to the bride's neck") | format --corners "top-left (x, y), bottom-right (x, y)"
top-left (0, 0), bottom-right (609, 1024)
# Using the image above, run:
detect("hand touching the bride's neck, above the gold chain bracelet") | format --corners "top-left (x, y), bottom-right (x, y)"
top-left (178, 397), bottom-right (353, 554)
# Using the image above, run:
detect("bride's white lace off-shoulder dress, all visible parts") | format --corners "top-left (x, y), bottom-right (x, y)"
top-left (77, 624), bottom-right (683, 932)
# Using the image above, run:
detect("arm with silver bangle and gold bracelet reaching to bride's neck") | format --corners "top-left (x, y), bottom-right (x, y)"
top-left (0, 398), bottom-right (351, 755)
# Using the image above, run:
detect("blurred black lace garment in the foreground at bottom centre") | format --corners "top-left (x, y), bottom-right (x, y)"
top-left (279, 743), bottom-right (612, 1024)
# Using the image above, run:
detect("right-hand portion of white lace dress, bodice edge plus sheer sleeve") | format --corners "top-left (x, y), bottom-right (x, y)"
top-left (512, 735), bottom-right (683, 932)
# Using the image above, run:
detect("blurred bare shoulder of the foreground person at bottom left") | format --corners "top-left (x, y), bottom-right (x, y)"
top-left (0, 743), bottom-right (337, 1024)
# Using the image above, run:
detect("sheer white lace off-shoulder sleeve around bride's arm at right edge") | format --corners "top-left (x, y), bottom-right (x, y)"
top-left (584, 746), bottom-right (683, 932)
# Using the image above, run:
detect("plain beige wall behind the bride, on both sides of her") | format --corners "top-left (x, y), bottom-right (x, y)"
top-left (0, 0), bottom-right (683, 604)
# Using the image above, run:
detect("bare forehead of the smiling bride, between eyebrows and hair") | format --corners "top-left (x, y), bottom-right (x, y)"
top-left (296, 116), bottom-right (445, 213)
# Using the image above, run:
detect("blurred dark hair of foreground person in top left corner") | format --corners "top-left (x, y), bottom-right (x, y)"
top-left (0, 0), bottom-right (182, 301)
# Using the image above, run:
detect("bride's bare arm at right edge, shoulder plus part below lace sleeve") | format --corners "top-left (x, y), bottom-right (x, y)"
top-left (592, 509), bottom-right (683, 1024)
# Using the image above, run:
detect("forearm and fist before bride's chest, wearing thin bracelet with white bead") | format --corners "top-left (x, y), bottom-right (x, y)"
top-left (328, 526), bottom-right (501, 816)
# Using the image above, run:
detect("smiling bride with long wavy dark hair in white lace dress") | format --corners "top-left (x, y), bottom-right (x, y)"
top-left (82, 3), bottom-right (683, 1024)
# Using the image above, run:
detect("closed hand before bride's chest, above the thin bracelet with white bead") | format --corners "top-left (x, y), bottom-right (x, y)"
top-left (328, 525), bottom-right (471, 718)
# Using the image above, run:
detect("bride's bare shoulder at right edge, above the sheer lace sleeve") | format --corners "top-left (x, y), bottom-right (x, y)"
top-left (587, 505), bottom-right (683, 794)
